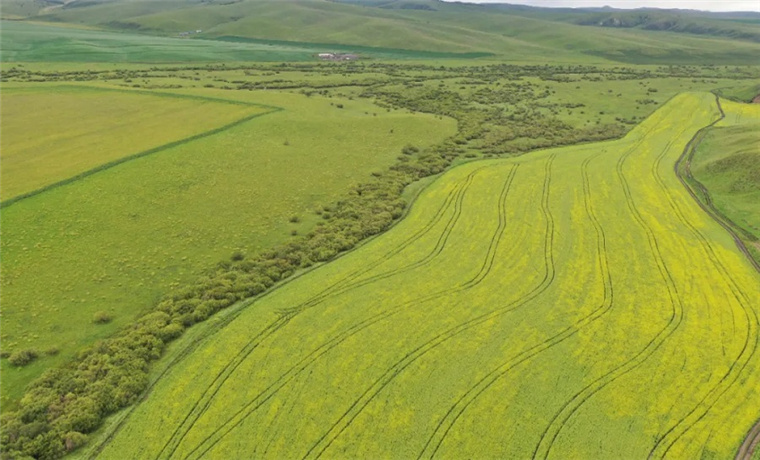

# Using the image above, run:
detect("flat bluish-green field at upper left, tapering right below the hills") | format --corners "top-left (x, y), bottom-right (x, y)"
top-left (0, 21), bottom-right (491, 63)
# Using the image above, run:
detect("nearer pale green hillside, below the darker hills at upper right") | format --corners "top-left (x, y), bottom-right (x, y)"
top-left (7, 0), bottom-right (760, 64)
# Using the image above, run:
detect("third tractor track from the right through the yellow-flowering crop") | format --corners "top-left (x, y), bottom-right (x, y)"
top-left (417, 150), bottom-right (614, 459)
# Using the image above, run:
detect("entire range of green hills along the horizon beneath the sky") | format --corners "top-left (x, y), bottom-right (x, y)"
top-left (2, 0), bottom-right (760, 64)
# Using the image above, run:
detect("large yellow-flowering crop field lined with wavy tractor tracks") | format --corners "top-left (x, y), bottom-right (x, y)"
top-left (92, 93), bottom-right (760, 459)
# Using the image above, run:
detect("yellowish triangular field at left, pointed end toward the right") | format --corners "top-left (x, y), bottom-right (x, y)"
top-left (0, 84), bottom-right (267, 201)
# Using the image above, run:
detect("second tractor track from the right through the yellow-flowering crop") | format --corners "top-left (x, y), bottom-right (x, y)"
top-left (532, 131), bottom-right (683, 459)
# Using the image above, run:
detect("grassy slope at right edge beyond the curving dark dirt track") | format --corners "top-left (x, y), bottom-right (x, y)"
top-left (692, 101), bottom-right (760, 256)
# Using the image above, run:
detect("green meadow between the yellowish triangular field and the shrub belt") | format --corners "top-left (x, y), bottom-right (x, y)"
top-left (2, 84), bottom-right (455, 403)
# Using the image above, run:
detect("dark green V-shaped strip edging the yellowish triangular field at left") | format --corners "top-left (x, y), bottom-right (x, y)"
top-left (0, 85), bottom-right (285, 209)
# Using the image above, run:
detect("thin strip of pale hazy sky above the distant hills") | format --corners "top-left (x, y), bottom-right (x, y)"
top-left (447, 0), bottom-right (760, 11)
